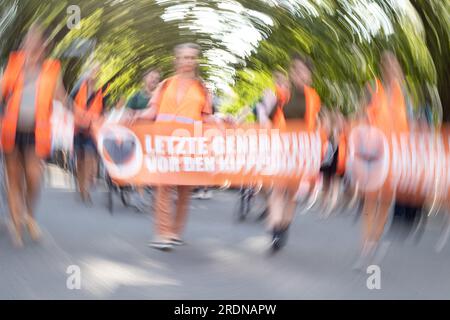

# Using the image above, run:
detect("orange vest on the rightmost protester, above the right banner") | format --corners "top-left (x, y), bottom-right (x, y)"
top-left (367, 79), bottom-right (409, 132)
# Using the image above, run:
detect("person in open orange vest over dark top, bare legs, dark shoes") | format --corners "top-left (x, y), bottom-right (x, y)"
top-left (257, 55), bottom-right (320, 251)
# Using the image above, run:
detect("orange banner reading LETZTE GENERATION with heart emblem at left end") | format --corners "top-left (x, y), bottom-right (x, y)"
top-left (95, 122), bottom-right (322, 188)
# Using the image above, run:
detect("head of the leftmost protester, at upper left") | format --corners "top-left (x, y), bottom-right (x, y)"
top-left (21, 22), bottom-right (47, 63)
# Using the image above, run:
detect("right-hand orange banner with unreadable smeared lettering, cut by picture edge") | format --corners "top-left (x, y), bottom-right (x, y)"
top-left (346, 123), bottom-right (450, 203)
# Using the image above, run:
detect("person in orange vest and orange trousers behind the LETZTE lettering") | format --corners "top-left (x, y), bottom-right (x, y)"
top-left (139, 43), bottom-right (221, 250)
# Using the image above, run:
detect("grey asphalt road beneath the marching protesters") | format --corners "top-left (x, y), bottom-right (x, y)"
top-left (0, 165), bottom-right (450, 299)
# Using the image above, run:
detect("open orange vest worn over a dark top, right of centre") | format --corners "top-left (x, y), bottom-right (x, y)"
top-left (273, 85), bottom-right (320, 131)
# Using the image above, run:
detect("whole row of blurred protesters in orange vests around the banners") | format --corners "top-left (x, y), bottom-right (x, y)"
top-left (0, 23), bottom-right (446, 270)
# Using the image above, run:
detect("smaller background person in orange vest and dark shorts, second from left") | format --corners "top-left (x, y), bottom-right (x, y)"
top-left (71, 63), bottom-right (105, 203)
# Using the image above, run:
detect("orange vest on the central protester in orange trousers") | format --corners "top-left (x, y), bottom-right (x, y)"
top-left (156, 76), bottom-right (208, 123)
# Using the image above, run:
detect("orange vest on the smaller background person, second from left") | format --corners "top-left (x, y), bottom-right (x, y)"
top-left (74, 81), bottom-right (103, 129)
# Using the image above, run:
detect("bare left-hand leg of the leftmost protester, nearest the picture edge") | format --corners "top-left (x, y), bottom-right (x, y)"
top-left (5, 147), bottom-right (25, 247)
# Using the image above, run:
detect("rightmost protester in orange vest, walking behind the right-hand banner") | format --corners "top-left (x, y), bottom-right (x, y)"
top-left (358, 52), bottom-right (409, 265)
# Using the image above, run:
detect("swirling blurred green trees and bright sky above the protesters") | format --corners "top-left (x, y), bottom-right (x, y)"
top-left (0, 0), bottom-right (450, 121)
